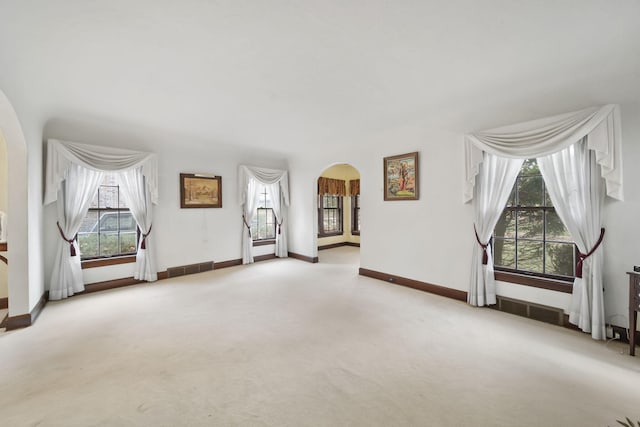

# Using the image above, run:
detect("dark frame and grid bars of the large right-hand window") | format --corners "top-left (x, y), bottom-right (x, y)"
top-left (491, 159), bottom-right (578, 292)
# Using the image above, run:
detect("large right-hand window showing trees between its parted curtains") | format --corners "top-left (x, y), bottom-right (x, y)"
top-left (493, 159), bottom-right (576, 279)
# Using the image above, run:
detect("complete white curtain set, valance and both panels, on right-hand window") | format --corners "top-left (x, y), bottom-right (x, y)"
top-left (464, 105), bottom-right (623, 339)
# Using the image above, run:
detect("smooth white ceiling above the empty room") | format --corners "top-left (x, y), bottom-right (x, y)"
top-left (0, 0), bottom-right (640, 151)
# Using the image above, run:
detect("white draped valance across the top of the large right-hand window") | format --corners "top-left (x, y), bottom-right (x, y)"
top-left (464, 104), bottom-right (623, 202)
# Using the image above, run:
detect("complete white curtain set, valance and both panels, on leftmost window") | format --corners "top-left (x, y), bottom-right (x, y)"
top-left (44, 139), bottom-right (158, 300)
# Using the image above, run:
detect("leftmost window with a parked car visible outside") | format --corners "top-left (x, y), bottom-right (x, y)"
top-left (78, 173), bottom-right (138, 260)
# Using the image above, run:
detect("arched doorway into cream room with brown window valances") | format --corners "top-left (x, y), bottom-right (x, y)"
top-left (316, 163), bottom-right (361, 265)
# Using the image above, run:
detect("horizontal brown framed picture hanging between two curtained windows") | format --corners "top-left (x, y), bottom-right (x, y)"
top-left (180, 173), bottom-right (222, 208)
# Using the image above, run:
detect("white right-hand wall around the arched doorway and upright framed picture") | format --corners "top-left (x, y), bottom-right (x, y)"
top-left (290, 103), bottom-right (640, 332)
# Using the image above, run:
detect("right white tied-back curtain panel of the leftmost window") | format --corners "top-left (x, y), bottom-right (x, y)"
top-left (118, 167), bottom-right (158, 282)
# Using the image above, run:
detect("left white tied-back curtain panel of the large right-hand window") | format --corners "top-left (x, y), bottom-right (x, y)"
top-left (467, 153), bottom-right (523, 306)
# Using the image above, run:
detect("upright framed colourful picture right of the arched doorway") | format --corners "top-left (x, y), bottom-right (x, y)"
top-left (384, 151), bottom-right (418, 200)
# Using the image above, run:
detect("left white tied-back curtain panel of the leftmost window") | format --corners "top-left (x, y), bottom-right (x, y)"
top-left (49, 164), bottom-right (103, 300)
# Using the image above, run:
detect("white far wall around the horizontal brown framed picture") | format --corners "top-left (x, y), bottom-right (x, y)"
top-left (44, 123), bottom-right (287, 288)
